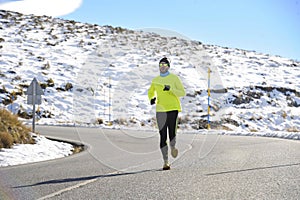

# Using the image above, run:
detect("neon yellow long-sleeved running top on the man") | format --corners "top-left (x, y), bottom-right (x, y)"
top-left (148, 73), bottom-right (185, 112)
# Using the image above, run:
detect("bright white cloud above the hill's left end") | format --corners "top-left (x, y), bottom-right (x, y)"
top-left (0, 0), bottom-right (83, 17)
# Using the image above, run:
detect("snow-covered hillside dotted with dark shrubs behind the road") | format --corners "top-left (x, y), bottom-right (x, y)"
top-left (0, 11), bottom-right (300, 139)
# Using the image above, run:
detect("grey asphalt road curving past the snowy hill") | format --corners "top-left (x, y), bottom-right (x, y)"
top-left (0, 127), bottom-right (300, 200)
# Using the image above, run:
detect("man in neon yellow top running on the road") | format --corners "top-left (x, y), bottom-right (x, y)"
top-left (148, 57), bottom-right (185, 170)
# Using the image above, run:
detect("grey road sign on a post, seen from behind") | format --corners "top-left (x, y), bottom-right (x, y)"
top-left (26, 78), bottom-right (44, 133)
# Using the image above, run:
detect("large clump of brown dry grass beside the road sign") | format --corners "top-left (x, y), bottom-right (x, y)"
top-left (0, 109), bottom-right (34, 148)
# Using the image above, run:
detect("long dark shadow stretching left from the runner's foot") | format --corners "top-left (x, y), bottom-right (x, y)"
top-left (13, 169), bottom-right (162, 188)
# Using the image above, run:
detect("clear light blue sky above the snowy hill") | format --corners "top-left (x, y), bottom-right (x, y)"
top-left (0, 0), bottom-right (300, 61)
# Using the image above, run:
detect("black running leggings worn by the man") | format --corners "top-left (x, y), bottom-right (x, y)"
top-left (156, 110), bottom-right (178, 160)
